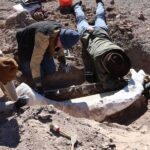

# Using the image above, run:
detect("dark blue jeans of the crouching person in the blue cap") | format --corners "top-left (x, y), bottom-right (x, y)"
top-left (20, 53), bottom-right (56, 79)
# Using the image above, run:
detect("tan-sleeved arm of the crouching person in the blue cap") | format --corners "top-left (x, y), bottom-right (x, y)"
top-left (30, 32), bottom-right (49, 78)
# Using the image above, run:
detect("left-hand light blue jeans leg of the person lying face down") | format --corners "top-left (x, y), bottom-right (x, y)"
top-left (74, 4), bottom-right (90, 35)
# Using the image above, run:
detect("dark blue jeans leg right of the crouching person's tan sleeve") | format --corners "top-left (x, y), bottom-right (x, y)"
top-left (41, 53), bottom-right (56, 79)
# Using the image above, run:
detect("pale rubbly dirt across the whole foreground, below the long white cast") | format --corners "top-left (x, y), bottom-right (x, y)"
top-left (0, 103), bottom-right (150, 150)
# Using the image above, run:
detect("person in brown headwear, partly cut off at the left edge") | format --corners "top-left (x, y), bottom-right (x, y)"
top-left (0, 56), bottom-right (28, 112)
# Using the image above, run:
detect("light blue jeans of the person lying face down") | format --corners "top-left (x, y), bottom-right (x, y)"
top-left (74, 3), bottom-right (108, 35)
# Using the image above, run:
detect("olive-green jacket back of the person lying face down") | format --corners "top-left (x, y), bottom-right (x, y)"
top-left (81, 29), bottom-right (123, 59)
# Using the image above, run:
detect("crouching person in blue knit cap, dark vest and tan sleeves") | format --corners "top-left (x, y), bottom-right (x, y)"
top-left (16, 21), bottom-right (79, 89)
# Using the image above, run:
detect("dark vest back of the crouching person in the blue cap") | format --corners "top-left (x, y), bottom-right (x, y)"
top-left (16, 21), bottom-right (61, 61)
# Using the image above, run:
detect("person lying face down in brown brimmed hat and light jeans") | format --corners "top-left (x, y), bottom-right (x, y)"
top-left (73, 0), bottom-right (131, 90)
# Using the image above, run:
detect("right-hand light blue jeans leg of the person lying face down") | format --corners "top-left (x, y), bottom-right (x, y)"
top-left (95, 2), bottom-right (108, 31)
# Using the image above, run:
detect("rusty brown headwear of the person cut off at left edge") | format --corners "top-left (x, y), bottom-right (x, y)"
top-left (0, 57), bottom-right (18, 84)
